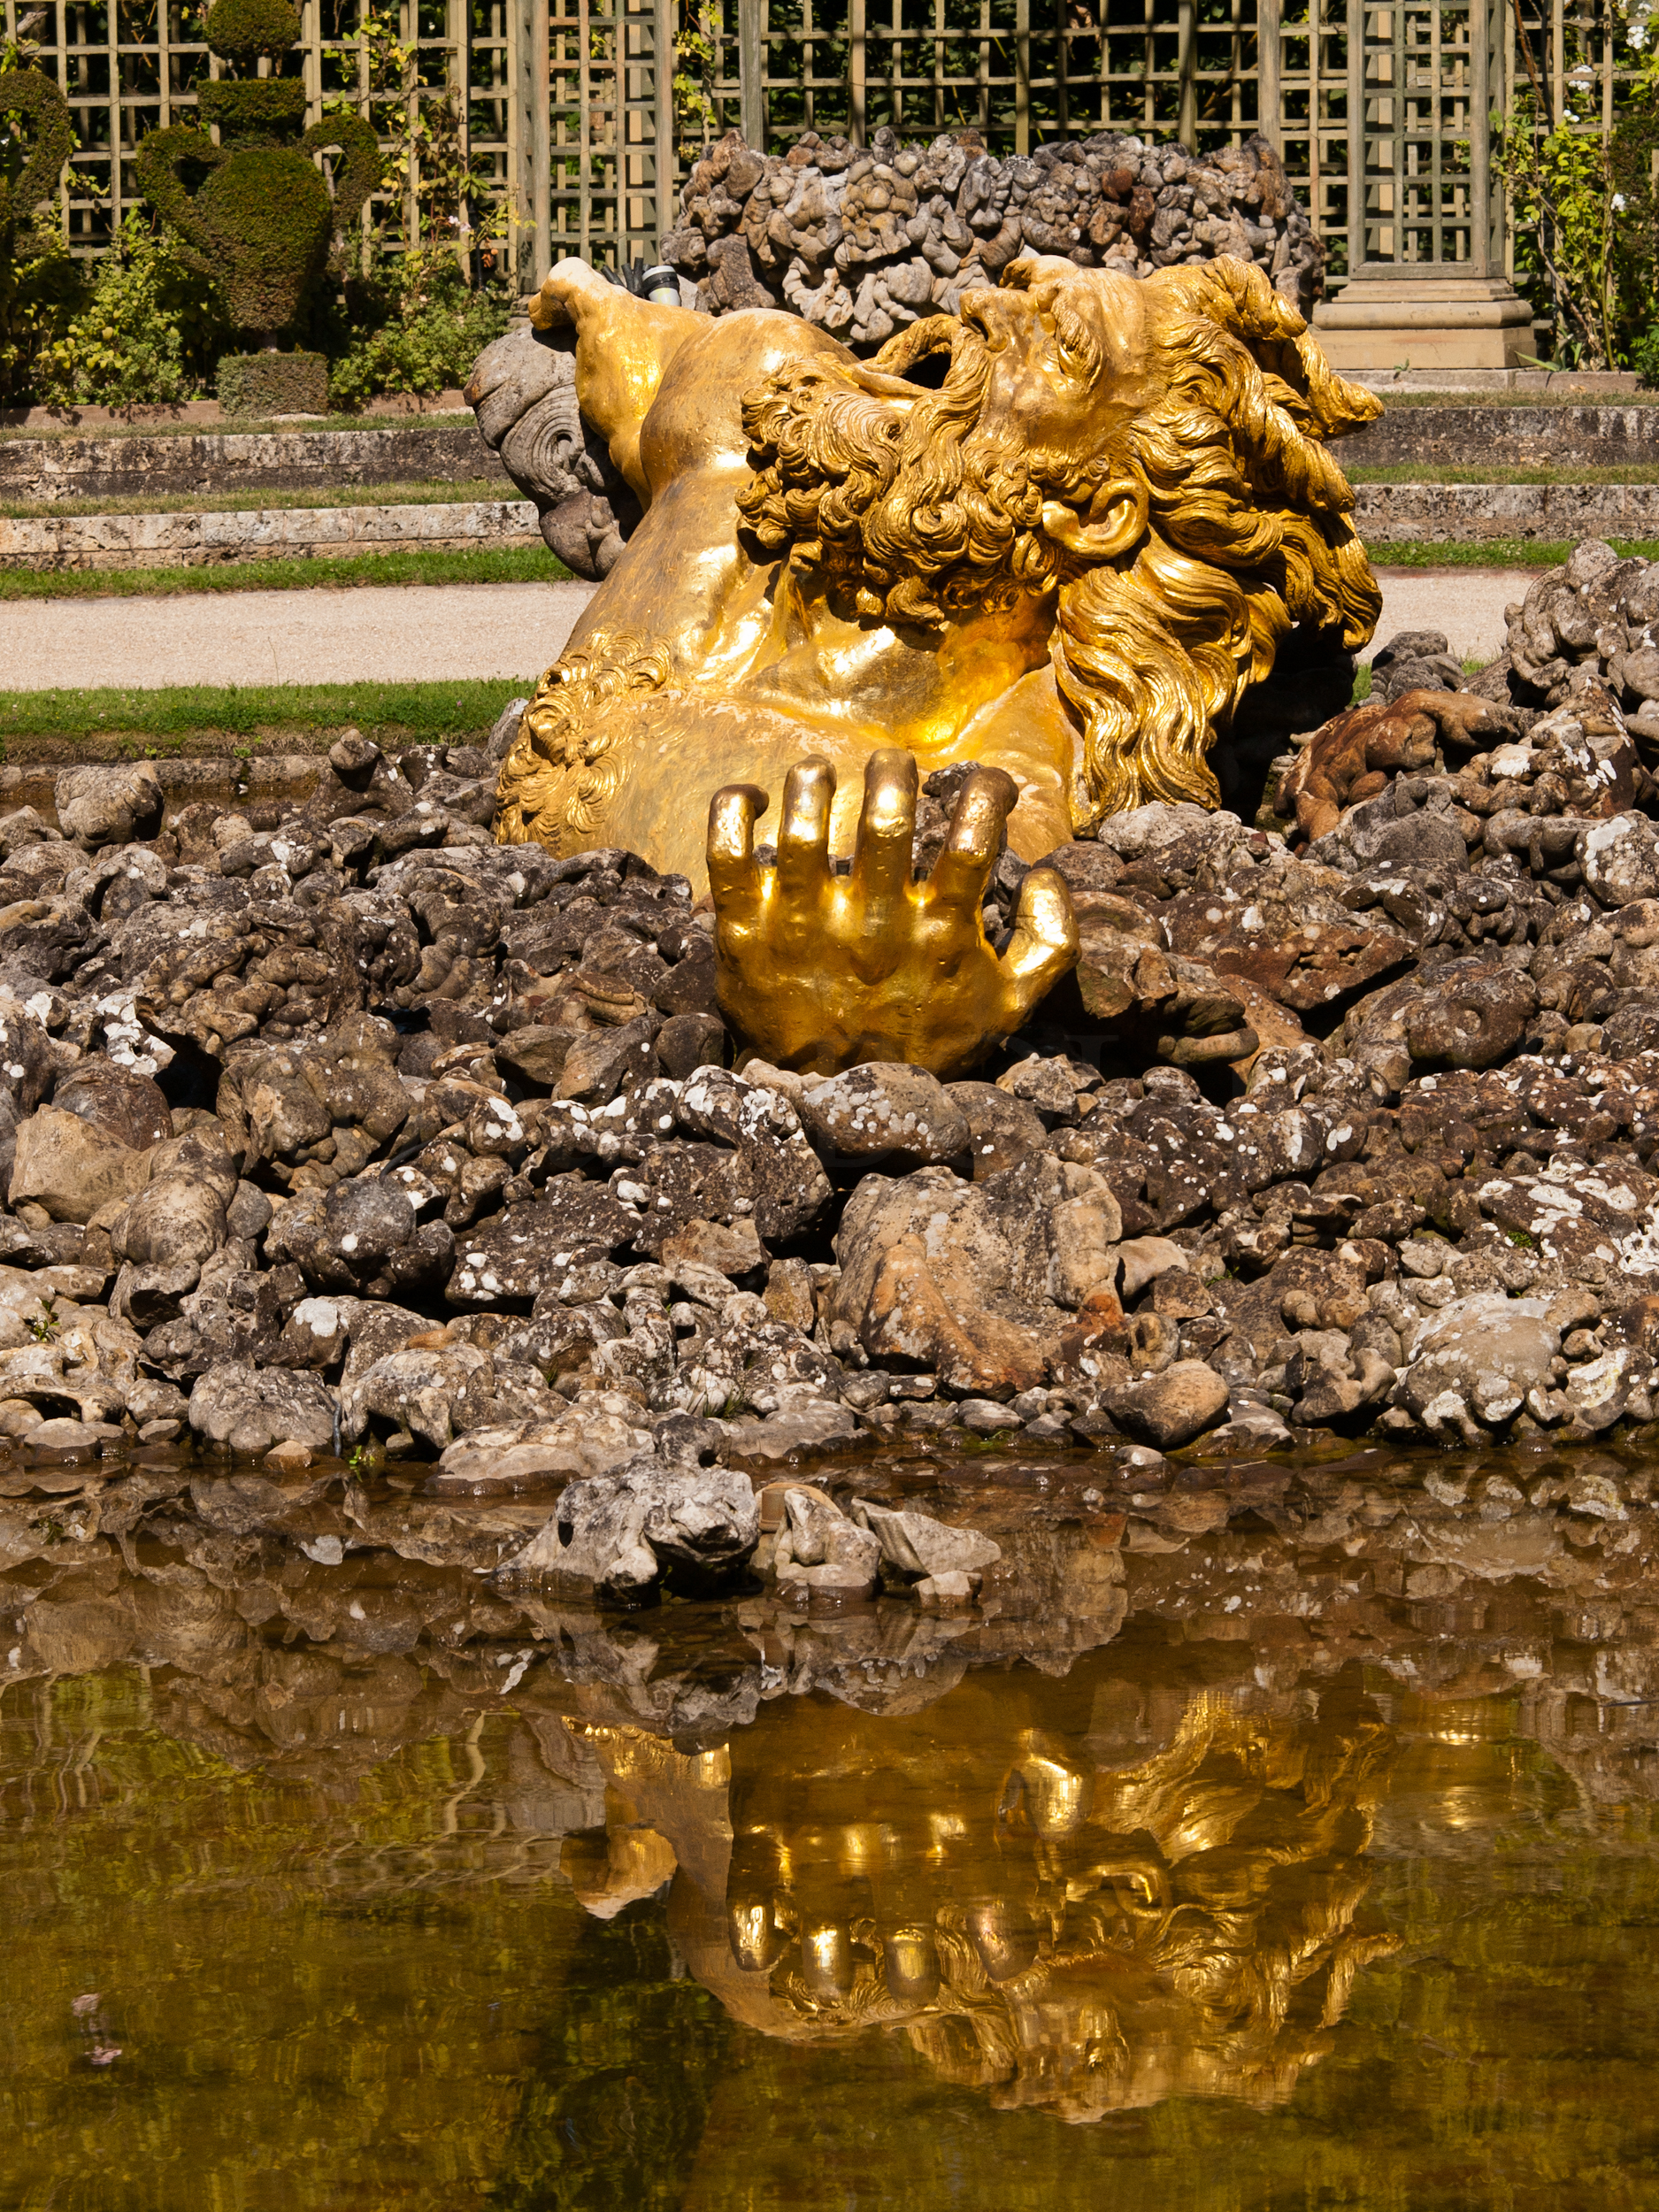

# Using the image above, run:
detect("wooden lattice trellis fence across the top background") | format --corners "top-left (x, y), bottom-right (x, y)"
top-left (0, 0), bottom-right (1626, 294)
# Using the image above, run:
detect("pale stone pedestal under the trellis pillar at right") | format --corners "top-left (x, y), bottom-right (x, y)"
top-left (1314, 265), bottom-right (1533, 370)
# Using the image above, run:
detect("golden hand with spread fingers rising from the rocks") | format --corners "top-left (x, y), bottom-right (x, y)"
top-left (708, 750), bottom-right (1078, 1079)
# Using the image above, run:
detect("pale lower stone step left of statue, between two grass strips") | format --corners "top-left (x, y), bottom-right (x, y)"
top-left (0, 500), bottom-right (542, 571)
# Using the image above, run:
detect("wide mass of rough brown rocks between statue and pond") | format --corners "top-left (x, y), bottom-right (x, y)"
top-left (0, 544), bottom-right (1659, 1604)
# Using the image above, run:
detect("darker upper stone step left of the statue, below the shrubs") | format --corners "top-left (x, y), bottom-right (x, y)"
top-left (0, 423), bottom-right (507, 503)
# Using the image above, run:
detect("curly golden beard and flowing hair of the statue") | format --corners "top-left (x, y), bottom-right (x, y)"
top-left (739, 259), bottom-right (1383, 832)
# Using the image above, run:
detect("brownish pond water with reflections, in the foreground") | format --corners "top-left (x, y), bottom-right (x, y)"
top-left (0, 1454), bottom-right (1659, 2212)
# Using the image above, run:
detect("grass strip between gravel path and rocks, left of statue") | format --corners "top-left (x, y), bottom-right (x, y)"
top-left (0, 675), bottom-right (535, 761)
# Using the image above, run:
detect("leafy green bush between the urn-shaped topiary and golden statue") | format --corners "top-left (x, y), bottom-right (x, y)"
top-left (326, 248), bottom-right (511, 410)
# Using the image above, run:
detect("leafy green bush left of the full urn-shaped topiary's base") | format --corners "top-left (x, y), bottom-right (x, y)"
top-left (34, 212), bottom-right (230, 407)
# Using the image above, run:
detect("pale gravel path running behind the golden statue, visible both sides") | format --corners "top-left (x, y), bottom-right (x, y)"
top-left (0, 569), bottom-right (1533, 690)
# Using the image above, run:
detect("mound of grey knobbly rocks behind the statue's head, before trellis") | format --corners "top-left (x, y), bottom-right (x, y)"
top-left (662, 127), bottom-right (1325, 348)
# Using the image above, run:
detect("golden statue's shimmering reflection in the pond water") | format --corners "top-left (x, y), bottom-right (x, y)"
top-left (559, 1671), bottom-right (1396, 2119)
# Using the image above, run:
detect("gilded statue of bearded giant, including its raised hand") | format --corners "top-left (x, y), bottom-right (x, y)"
top-left (480, 257), bottom-right (1380, 1073)
